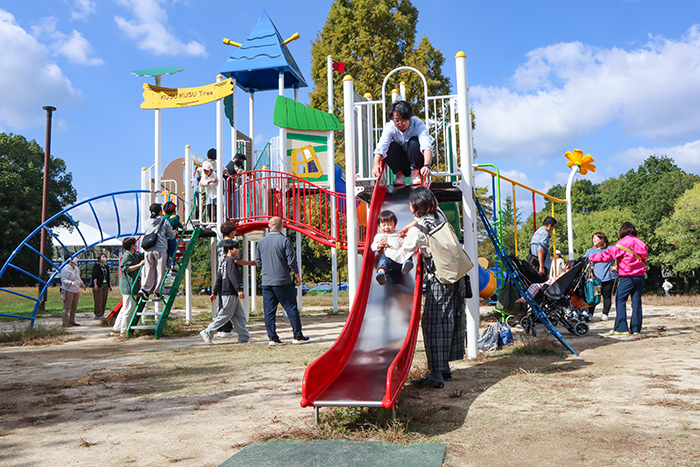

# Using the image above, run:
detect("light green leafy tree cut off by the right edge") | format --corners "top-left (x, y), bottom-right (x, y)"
top-left (656, 183), bottom-right (700, 276)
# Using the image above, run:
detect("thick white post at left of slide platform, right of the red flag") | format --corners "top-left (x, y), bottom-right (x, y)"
top-left (343, 75), bottom-right (359, 307)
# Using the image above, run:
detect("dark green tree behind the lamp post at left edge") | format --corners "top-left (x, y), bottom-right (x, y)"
top-left (0, 133), bottom-right (76, 286)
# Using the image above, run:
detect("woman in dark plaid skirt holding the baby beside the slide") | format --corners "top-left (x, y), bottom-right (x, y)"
top-left (397, 187), bottom-right (467, 388)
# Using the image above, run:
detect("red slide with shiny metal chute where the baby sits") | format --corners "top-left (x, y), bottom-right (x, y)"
top-left (301, 180), bottom-right (422, 409)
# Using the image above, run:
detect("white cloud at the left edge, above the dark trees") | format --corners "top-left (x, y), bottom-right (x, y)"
top-left (0, 9), bottom-right (81, 130)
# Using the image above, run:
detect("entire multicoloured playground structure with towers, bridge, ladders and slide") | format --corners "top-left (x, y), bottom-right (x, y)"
top-left (0, 11), bottom-right (584, 416)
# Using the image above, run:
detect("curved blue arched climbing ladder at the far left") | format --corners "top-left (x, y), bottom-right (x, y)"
top-left (0, 190), bottom-right (151, 326)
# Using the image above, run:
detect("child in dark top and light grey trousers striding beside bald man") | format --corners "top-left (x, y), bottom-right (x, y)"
top-left (199, 239), bottom-right (255, 344)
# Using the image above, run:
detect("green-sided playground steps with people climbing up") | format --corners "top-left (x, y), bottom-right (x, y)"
top-left (126, 227), bottom-right (203, 339)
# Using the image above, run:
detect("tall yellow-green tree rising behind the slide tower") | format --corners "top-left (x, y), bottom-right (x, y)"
top-left (310, 0), bottom-right (450, 163)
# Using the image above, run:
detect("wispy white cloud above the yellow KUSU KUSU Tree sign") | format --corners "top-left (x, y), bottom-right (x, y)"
top-left (114, 0), bottom-right (207, 57)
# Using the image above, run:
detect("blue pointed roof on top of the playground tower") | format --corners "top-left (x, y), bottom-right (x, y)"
top-left (221, 10), bottom-right (307, 92)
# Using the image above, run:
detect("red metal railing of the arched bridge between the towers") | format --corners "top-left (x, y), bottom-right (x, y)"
top-left (227, 170), bottom-right (367, 250)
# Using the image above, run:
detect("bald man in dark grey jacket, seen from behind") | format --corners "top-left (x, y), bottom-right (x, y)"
top-left (255, 217), bottom-right (309, 345)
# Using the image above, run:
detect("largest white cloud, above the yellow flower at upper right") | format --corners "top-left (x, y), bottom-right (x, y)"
top-left (471, 25), bottom-right (700, 161)
